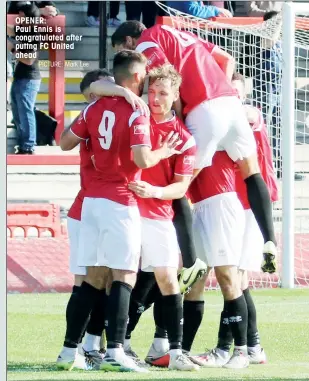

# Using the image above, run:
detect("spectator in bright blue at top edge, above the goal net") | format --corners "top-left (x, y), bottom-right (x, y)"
top-left (166, 1), bottom-right (233, 19)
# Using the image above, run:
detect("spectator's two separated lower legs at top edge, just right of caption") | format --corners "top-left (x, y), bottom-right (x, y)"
top-left (86, 1), bottom-right (121, 28)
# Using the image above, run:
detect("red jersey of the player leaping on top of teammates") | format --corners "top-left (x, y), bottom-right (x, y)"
top-left (136, 25), bottom-right (237, 115)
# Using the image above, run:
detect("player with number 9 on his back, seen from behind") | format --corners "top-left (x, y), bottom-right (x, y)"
top-left (56, 51), bottom-right (181, 372)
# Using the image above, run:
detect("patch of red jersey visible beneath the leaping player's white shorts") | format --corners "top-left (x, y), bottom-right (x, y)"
top-left (189, 151), bottom-right (236, 204)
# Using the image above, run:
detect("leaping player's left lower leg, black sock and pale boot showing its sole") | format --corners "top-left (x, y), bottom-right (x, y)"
top-left (172, 197), bottom-right (207, 294)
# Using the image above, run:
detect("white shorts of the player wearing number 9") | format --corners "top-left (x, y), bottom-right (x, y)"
top-left (78, 197), bottom-right (141, 271)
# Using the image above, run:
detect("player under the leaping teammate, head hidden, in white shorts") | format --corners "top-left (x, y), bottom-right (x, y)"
top-left (184, 151), bottom-right (249, 369)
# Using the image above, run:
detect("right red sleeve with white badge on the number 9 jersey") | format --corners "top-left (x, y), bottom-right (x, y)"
top-left (129, 110), bottom-right (152, 148)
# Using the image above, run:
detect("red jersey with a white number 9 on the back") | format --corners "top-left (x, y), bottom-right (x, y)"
top-left (71, 97), bottom-right (151, 205)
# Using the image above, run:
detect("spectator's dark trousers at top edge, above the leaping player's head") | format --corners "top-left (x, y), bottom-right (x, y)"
top-left (125, 1), bottom-right (158, 28)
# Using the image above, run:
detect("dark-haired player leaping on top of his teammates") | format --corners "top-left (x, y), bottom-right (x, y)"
top-left (112, 21), bottom-right (277, 273)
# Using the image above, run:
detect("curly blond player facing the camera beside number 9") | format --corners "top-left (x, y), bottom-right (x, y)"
top-left (89, 65), bottom-right (198, 370)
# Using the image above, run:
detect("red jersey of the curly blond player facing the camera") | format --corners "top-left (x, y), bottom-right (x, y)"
top-left (138, 116), bottom-right (196, 220)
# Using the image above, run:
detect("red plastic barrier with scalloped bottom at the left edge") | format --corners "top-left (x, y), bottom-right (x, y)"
top-left (7, 204), bottom-right (63, 238)
